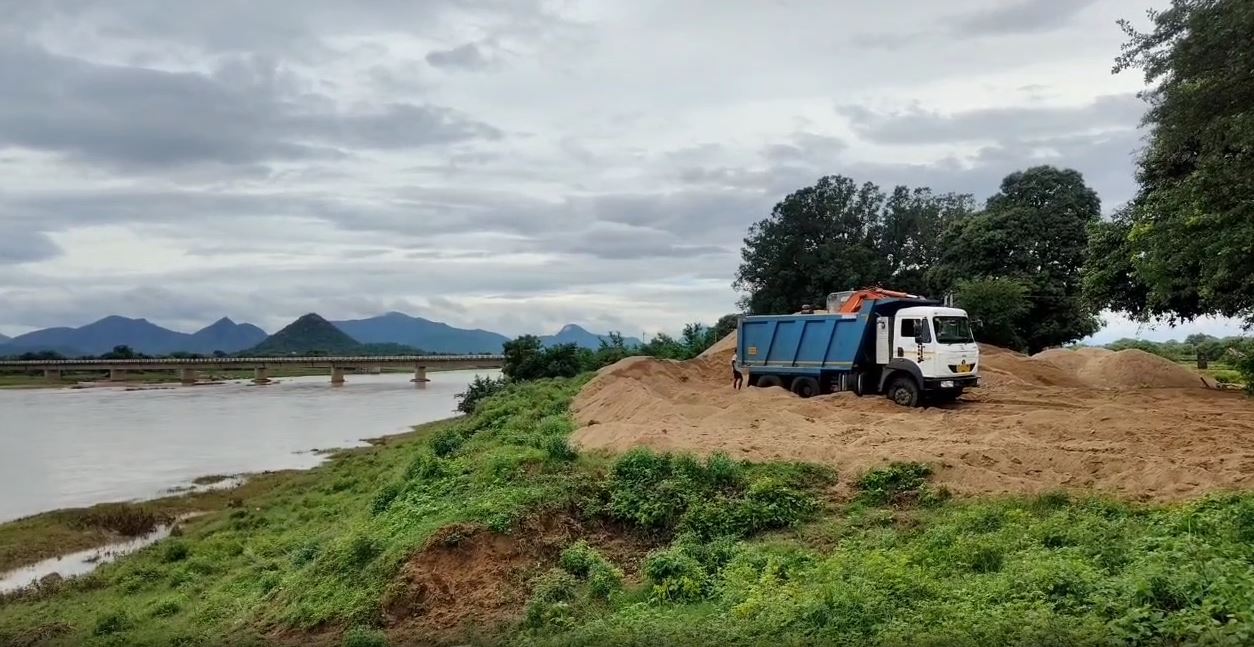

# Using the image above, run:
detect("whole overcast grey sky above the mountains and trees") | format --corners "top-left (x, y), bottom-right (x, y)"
top-left (0, 0), bottom-right (1236, 337)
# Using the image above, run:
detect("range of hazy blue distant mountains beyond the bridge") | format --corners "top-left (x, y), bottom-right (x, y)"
top-left (0, 312), bottom-right (641, 357)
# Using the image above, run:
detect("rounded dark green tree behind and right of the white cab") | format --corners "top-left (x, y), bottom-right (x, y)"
top-left (929, 167), bottom-right (1101, 352)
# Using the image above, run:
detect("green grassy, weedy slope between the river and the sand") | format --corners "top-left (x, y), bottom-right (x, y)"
top-left (0, 381), bottom-right (1254, 644)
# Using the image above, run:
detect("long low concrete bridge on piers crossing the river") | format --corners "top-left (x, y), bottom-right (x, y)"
top-left (0, 355), bottom-right (504, 385)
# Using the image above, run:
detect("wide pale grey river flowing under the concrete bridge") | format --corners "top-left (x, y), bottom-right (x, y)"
top-left (0, 371), bottom-right (499, 522)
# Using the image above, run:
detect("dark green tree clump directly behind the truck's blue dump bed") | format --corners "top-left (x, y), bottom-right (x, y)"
top-left (735, 176), bottom-right (972, 313)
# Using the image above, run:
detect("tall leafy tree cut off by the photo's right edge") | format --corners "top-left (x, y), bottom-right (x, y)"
top-left (1086, 0), bottom-right (1254, 321)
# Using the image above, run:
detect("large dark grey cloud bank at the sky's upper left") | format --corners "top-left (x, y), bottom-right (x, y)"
top-left (0, 43), bottom-right (500, 169)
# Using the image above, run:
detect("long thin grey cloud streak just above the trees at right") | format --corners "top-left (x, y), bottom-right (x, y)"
top-left (838, 94), bottom-right (1145, 144)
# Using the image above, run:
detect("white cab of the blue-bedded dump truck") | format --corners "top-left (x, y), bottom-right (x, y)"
top-left (875, 306), bottom-right (979, 404)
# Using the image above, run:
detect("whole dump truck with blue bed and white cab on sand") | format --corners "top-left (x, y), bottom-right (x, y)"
top-left (736, 287), bottom-right (979, 406)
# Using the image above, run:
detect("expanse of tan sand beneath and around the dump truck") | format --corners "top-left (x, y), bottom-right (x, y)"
top-left (573, 340), bottom-right (1254, 500)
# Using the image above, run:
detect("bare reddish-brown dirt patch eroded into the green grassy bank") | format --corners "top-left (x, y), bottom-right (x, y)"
top-left (384, 514), bottom-right (653, 644)
